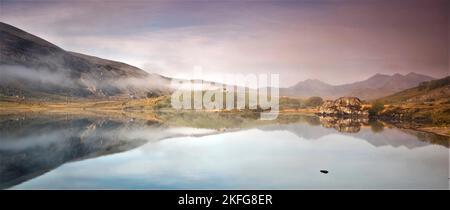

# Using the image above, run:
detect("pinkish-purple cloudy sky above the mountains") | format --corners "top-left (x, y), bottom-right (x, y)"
top-left (0, 0), bottom-right (450, 86)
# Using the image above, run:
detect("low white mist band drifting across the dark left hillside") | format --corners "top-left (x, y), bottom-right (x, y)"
top-left (0, 65), bottom-right (170, 97)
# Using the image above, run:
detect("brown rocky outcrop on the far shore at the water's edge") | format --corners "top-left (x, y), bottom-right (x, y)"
top-left (317, 97), bottom-right (369, 116)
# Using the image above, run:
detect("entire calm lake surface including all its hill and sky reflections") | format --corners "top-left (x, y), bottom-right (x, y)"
top-left (0, 112), bottom-right (449, 189)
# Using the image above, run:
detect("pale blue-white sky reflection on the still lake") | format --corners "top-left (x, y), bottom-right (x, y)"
top-left (12, 124), bottom-right (449, 189)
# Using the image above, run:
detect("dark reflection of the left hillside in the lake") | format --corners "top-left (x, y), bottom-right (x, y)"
top-left (0, 115), bottom-right (214, 188)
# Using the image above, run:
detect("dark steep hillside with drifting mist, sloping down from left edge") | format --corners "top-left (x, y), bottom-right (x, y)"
top-left (0, 22), bottom-right (170, 99)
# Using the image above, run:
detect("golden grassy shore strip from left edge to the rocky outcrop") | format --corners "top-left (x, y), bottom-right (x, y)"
top-left (0, 93), bottom-right (320, 129)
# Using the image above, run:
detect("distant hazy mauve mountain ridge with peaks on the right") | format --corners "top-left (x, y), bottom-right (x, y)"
top-left (280, 72), bottom-right (434, 100)
